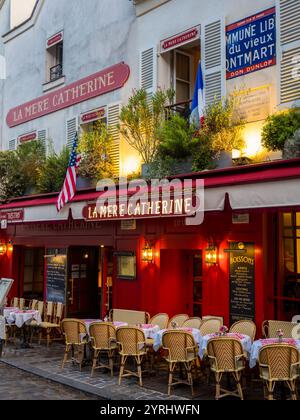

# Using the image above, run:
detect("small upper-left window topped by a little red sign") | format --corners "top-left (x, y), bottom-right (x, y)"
top-left (46, 33), bottom-right (64, 82)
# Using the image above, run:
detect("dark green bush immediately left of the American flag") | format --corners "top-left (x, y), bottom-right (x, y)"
top-left (37, 147), bottom-right (70, 193)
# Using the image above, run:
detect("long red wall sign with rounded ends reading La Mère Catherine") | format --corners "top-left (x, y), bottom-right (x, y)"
top-left (6, 63), bottom-right (130, 128)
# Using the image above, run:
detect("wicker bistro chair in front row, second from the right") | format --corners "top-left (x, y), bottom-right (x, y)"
top-left (207, 337), bottom-right (246, 400)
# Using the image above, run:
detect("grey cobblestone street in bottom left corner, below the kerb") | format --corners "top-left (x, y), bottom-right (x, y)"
top-left (0, 363), bottom-right (99, 401)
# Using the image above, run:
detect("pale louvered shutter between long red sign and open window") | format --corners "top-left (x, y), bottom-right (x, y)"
top-left (140, 48), bottom-right (157, 96)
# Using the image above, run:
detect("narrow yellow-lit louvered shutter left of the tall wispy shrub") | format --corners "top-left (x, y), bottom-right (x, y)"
top-left (107, 104), bottom-right (120, 177)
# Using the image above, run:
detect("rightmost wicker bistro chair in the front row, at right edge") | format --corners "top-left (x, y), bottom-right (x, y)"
top-left (259, 344), bottom-right (300, 400)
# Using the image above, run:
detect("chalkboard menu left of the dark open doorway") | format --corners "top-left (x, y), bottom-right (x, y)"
top-left (45, 249), bottom-right (67, 304)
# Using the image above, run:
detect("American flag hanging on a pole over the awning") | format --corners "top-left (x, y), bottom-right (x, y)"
top-left (56, 133), bottom-right (81, 212)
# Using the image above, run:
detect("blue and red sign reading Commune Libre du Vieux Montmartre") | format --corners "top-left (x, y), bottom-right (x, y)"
top-left (226, 7), bottom-right (276, 80)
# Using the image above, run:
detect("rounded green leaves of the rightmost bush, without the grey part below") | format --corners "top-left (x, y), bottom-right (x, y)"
top-left (262, 109), bottom-right (300, 151)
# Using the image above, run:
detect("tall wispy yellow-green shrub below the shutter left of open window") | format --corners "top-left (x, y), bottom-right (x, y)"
top-left (120, 89), bottom-right (174, 164)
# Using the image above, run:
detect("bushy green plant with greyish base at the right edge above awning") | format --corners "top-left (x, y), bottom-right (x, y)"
top-left (262, 109), bottom-right (300, 159)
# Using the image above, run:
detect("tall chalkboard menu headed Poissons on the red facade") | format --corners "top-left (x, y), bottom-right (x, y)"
top-left (230, 242), bottom-right (255, 324)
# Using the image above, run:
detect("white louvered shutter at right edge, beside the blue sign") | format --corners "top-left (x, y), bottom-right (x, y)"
top-left (277, 0), bottom-right (300, 106)
